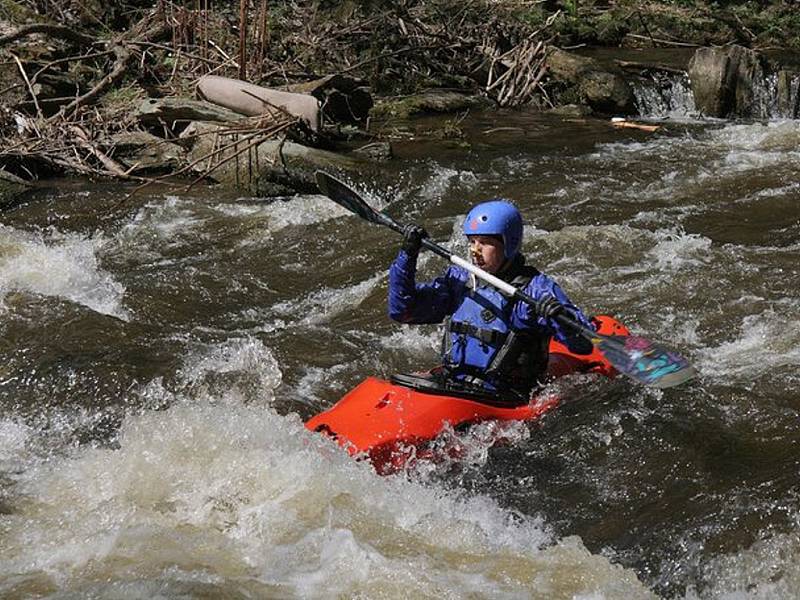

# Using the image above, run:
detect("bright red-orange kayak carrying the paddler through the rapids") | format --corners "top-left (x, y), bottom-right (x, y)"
top-left (306, 316), bottom-right (629, 475)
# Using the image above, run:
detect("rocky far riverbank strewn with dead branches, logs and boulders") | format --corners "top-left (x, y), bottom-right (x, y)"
top-left (0, 0), bottom-right (798, 205)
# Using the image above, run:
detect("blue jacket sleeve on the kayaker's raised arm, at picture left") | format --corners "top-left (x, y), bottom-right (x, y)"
top-left (389, 250), bottom-right (463, 324)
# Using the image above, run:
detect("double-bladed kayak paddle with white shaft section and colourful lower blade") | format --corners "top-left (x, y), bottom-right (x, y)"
top-left (316, 171), bottom-right (697, 388)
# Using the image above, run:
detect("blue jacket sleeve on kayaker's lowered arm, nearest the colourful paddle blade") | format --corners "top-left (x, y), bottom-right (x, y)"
top-left (513, 274), bottom-right (595, 354)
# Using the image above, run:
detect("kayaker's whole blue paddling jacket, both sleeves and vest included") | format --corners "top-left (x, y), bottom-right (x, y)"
top-left (389, 250), bottom-right (593, 400)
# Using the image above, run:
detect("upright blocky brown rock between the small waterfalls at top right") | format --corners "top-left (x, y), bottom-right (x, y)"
top-left (689, 46), bottom-right (764, 118)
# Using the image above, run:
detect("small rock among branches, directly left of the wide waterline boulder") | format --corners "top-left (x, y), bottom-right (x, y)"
top-left (107, 131), bottom-right (187, 175)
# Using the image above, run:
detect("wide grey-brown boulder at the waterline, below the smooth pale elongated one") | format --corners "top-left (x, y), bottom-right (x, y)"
top-left (181, 122), bottom-right (362, 196)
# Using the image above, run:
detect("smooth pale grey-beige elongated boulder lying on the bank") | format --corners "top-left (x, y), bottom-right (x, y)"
top-left (197, 75), bottom-right (320, 131)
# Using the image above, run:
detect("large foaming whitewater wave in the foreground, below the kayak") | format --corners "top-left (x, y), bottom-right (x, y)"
top-left (0, 392), bottom-right (651, 598)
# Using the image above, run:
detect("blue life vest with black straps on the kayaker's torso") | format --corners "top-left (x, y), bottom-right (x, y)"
top-left (442, 265), bottom-right (550, 400)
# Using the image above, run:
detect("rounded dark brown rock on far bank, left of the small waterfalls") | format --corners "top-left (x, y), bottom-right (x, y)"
top-left (547, 49), bottom-right (636, 114)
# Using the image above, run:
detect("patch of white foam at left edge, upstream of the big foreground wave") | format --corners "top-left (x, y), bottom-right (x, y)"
top-left (0, 225), bottom-right (130, 320)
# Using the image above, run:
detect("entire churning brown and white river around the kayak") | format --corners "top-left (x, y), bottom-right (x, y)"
top-left (0, 112), bottom-right (800, 599)
